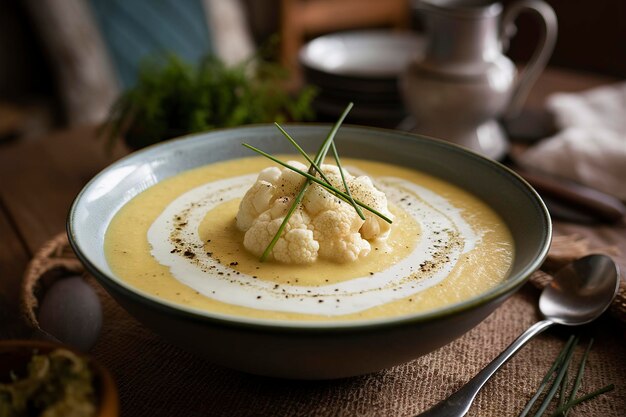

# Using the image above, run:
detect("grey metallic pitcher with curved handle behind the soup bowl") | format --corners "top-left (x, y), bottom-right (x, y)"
top-left (402, 0), bottom-right (557, 159)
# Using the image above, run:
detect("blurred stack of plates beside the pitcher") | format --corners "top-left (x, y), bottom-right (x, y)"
top-left (299, 30), bottom-right (424, 128)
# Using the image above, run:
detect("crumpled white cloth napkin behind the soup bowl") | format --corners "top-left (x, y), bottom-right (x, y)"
top-left (518, 82), bottom-right (626, 200)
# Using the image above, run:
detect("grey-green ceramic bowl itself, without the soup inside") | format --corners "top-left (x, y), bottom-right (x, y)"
top-left (67, 125), bottom-right (551, 379)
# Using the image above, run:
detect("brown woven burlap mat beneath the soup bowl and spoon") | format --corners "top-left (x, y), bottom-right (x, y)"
top-left (22, 235), bottom-right (626, 417)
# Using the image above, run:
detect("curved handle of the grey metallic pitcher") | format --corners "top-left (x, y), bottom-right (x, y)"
top-left (500, 0), bottom-right (558, 118)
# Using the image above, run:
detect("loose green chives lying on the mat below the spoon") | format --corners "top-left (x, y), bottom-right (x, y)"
top-left (519, 336), bottom-right (615, 417)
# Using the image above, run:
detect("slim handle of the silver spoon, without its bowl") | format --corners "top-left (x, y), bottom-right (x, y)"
top-left (418, 320), bottom-right (554, 417)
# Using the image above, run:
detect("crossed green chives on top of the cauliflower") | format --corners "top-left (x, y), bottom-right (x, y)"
top-left (243, 103), bottom-right (392, 262)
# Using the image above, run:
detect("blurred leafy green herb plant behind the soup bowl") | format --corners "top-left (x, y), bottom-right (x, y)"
top-left (100, 54), bottom-right (315, 148)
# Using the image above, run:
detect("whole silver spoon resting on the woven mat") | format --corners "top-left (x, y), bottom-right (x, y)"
top-left (418, 255), bottom-right (619, 417)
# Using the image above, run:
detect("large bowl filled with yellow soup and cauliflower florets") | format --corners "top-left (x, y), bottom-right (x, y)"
top-left (68, 125), bottom-right (551, 379)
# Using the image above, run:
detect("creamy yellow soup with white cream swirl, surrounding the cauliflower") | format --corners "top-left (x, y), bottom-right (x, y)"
top-left (105, 156), bottom-right (513, 320)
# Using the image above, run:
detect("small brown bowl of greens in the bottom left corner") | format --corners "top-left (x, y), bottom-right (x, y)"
top-left (0, 340), bottom-right (119, 417)
